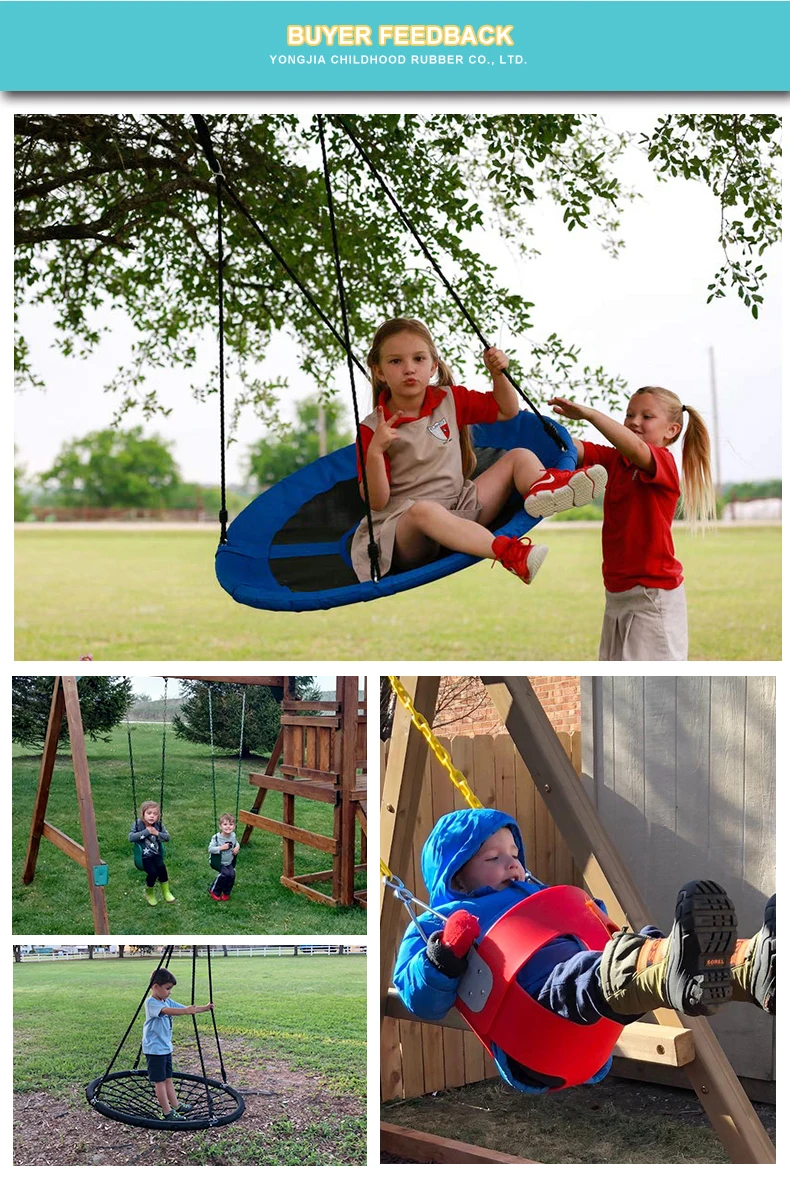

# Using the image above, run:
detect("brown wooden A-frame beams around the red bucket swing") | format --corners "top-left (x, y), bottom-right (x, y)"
top-left (380, 676), bottom-right (776, 1164)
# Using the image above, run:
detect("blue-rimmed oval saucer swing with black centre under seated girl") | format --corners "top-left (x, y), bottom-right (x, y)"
top-left (216, 410), bottom-right (577, 611)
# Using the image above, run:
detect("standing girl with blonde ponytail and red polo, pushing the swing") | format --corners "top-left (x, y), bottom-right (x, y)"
top-left (537, 386), bottom-right (716, 660)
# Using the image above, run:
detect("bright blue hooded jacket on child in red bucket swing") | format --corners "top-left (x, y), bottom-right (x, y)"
top-left (394, 808), bottom-right (612, 1093)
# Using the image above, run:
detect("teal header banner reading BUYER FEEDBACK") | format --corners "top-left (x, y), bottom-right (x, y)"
top-left (0, 0), bottom-right (790, 93)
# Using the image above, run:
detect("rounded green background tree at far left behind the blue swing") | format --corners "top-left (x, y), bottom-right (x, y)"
top-left (41, 426), bottom-right (179, 508)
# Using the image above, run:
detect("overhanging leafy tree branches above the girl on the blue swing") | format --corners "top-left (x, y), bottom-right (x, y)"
top-left (15, 113), bottom-right (781, 422)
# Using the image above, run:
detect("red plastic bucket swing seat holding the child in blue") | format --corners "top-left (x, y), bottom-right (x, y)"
top-left (455, 884), bottom-right (623, 1088)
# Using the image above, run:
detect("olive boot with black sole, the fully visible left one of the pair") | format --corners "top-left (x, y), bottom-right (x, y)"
top-left (600, 881), bottom-right (737, 1015)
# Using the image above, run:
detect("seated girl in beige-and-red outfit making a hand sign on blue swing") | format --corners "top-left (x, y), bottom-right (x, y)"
top-left (351, 318), bottom-right (606, 584)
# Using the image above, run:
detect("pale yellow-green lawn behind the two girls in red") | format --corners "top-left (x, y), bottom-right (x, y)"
top-left (15, 526), bottom-right (782, 660)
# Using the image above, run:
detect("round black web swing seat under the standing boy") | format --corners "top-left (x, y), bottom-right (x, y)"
top-left (85, 1068), bottom-right (244, 1129)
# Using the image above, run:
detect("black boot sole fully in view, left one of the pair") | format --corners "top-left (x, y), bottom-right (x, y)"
top-left (665, 881), bottom-right (738, 1015)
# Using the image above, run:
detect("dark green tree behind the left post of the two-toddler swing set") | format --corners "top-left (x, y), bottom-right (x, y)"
top-left (11, 676), bottom-right (132, 749)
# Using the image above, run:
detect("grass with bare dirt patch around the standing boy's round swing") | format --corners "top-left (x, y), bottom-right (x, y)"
top-left (14, 950), bottom-right (367, 1166)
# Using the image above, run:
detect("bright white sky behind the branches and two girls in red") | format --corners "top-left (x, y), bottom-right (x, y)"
top-left (15, 103), bottom-right (782, 483)
